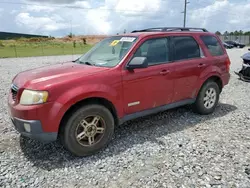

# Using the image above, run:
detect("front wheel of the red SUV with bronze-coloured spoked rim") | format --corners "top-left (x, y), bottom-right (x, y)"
top-left (60, 104), bottom-right (114, 157)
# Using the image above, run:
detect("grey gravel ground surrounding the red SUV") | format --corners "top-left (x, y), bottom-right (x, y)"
top-left (0, 49), bottom-right (250, 188)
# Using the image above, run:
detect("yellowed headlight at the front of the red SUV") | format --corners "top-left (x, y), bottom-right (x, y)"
top-left (20, 89), bottom-right (48, 105)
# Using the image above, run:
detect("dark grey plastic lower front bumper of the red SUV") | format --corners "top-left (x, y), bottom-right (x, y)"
top-left (11, 118), bottom-right (57, 143)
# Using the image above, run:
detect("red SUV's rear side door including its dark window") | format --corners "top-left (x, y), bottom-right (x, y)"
top-left (172, 35), bottom-right (208, 102)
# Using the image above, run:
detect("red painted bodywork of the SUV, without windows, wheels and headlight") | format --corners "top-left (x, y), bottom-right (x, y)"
top-left (9, 32), bottom-right (230, 132)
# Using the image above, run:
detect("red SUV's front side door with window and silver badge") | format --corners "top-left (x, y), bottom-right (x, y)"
top-left (122, 37), bottom-right (174, 114)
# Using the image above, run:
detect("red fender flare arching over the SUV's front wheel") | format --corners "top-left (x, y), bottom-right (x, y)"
top-left (54, 83), bottom-right (123, 131)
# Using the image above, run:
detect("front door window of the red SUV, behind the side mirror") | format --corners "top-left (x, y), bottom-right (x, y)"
top-left (134, 38), bottom-right (169, 65)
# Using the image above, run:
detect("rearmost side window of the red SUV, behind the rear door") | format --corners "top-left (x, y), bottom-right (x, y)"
top-left (201, 36), bottom-right (224, 56)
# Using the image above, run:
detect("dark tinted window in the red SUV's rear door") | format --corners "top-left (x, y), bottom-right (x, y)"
top-left (173, 36), bottom-right (201, 60)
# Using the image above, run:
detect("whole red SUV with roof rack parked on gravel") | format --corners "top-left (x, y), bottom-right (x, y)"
top-left (8, 28), bottom-right (230, 156)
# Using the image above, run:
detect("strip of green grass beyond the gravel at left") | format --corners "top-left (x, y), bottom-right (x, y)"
top-left (0, 41), bottom-right (92, 58)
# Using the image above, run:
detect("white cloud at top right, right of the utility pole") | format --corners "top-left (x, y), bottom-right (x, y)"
top-left (189, 0), bottom-right (250, 32)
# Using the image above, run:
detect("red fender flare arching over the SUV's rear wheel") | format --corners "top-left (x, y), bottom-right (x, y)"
top-left (195, 66), bottom-right (222, 97)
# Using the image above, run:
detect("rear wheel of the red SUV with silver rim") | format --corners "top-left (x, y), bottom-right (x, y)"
top-left (194, 81), bottom-right (220, 115)
